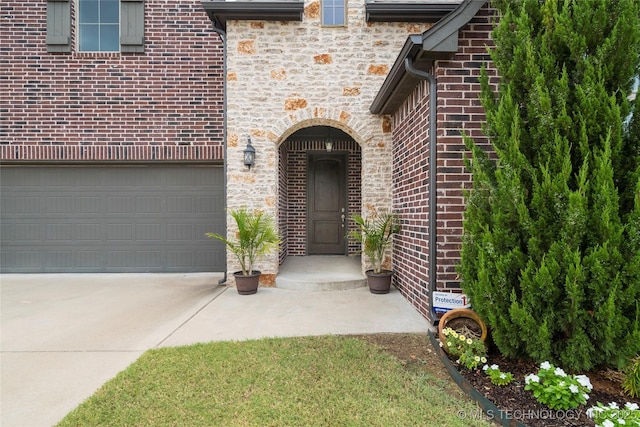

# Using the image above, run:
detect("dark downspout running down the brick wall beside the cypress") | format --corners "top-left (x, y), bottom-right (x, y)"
top-left (404, 58), bottom-right (438, 325)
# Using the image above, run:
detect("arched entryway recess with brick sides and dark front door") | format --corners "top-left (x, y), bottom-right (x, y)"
top-left (278, 126), bottom-right (362, 264)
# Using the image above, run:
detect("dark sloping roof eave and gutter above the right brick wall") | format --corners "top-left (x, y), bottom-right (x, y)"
top-left (369, 0), bottom-right (485, 114)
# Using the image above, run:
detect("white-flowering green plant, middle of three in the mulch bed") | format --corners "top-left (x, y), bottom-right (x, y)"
top-left (524, 362), bottom-right (593, 409)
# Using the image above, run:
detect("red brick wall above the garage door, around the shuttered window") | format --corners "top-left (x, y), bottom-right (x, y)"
top-left (0, 0), bottom-right (223, 161)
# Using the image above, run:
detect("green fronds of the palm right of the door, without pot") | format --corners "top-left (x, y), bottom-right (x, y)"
top-left (349, 212), bottom-right (400, 274)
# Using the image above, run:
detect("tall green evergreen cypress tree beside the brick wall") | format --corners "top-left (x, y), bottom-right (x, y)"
top-left (459, 0), bottom-right (640, 370)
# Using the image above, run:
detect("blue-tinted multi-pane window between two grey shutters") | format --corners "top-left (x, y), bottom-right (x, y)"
top-left (78, 0), bottom-right (120, 52)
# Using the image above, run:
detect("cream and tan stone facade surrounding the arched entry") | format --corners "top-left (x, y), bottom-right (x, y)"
top-left (222, 0), bottom-right (438, 281)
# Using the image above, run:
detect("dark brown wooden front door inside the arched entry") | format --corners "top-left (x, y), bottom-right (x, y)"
top-left (307, 153), bottom-right (347, 255)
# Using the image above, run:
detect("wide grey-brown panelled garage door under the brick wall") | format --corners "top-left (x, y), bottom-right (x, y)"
top-left (0, 165), bottom-right (225, 273)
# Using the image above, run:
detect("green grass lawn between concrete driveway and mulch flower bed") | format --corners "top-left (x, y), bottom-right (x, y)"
top-left (59, 336), bottom-right (490, 427)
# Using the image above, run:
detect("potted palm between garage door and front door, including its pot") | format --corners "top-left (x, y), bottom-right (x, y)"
top-left (207, 207), bottom-right (280, 295)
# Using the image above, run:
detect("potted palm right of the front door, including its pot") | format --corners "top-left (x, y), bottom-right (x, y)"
top-left (349, 212), bottom-right (400, 294)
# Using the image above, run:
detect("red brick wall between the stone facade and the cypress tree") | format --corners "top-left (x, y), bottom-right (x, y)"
top-left (393, 6), bottom-right (497, 317)
